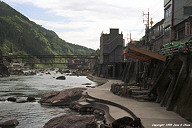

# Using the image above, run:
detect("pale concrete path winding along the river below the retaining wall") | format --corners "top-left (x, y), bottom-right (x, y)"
top-left (87, 80), bottom-right (192, 128)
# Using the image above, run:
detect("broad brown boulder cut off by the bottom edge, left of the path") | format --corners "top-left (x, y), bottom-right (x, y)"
top-left (43, 115), bottom-right (97, 128)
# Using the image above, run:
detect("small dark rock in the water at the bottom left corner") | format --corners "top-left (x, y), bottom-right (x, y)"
top-left (0, 119), bottom-right (19, 128)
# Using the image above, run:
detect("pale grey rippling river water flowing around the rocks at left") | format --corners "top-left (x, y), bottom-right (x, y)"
top-left (0, 71), bottom-right (96, 128)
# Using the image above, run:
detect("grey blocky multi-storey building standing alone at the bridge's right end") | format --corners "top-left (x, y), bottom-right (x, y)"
top-left (99, 29), bottom-right (124, 77)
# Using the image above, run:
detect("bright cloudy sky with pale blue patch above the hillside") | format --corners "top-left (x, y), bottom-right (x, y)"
top-left (2, 0), bottom-right (164, 50)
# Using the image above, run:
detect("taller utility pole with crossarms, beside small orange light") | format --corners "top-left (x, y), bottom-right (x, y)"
top-left (143, 9), bottom-right (150, 45)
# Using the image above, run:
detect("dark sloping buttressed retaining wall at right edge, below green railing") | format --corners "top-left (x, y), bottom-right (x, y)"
top-left (149, 54), bottom-right (192, 121)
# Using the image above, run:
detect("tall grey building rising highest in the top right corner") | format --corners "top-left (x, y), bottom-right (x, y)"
top-left (163, 0), bottom-right (192, 44)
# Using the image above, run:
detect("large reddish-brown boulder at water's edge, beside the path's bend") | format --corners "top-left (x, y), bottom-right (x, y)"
top-left (39, 88), bottom-right (86, 106)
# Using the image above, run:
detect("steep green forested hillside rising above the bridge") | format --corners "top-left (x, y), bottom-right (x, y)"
top-left (0, 1), bottom-right (94, 55)
